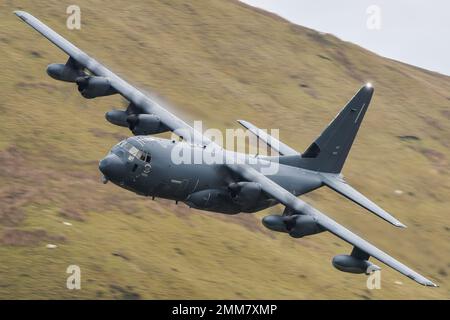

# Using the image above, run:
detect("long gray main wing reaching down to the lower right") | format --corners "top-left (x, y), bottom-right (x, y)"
top-left (227, 164), bottom-right (437, 287)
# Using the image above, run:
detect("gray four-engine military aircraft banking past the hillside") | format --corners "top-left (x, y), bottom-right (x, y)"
top-left (15, 11), bottom-right (436, 286)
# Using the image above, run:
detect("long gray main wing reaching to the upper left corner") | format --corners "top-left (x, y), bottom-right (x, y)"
top-left (14, 11), bottom-right (213, 145)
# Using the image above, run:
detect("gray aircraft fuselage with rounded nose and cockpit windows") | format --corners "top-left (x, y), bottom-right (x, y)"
top-left (99, 136), bottom-right (322, 214)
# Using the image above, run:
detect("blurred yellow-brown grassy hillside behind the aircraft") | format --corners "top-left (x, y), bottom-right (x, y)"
top-left (0, 0), bottom-right (450, 299)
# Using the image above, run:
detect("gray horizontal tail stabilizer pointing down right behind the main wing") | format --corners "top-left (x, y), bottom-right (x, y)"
top-left (321, 173), bottom-right (406, 228)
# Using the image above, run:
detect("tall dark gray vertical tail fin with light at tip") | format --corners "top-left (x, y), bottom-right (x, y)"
top-left (299, 84), bottom-right (374, 173)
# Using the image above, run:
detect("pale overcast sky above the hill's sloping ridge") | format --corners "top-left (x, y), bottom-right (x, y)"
top-left (241, 0), bottom-right (450, 75)
